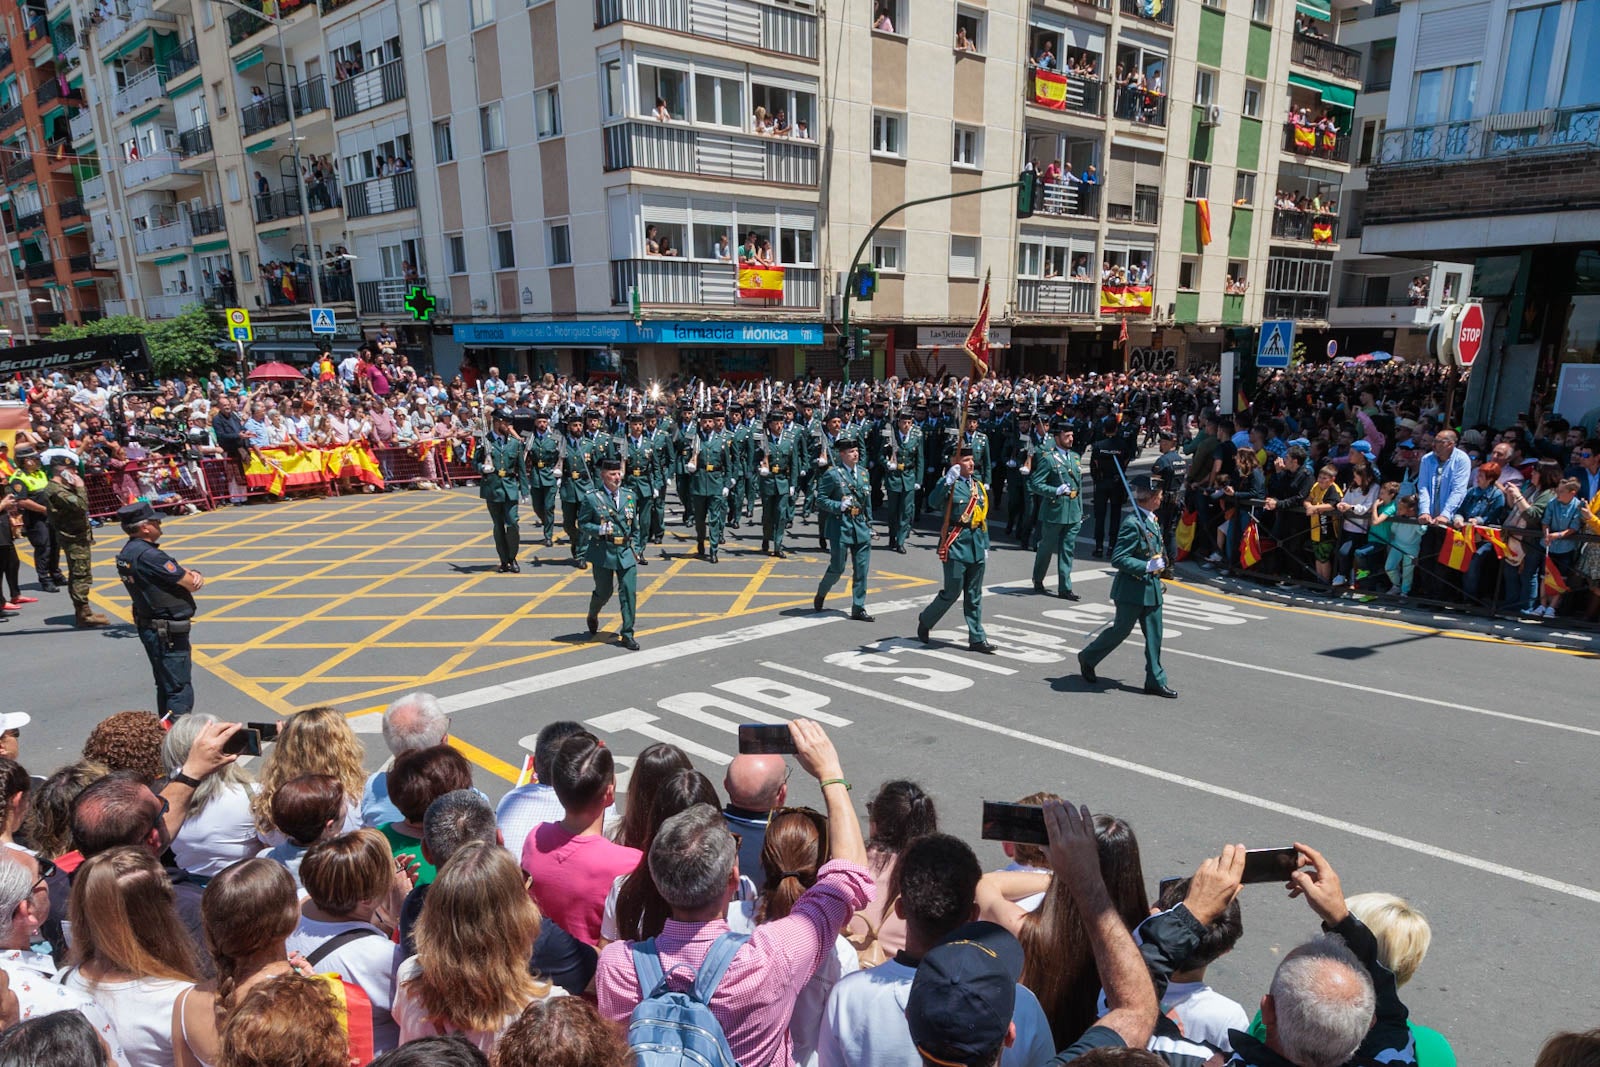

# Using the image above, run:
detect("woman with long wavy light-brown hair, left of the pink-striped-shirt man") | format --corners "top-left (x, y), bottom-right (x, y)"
top-left (394, 841), bottom-right (566, 1053)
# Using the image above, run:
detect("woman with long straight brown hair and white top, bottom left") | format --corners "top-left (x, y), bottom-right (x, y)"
top-left (61, 845), bottom-right (200, 1064)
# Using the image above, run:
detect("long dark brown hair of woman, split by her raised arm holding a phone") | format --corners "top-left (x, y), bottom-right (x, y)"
top-left (1018, 816), bottom-right (1150, 1048)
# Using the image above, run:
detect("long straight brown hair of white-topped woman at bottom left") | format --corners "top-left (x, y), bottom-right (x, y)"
top-left (67, 845), bottom-right (200, 982)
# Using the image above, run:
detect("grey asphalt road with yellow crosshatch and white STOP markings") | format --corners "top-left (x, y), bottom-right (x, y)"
top-left (0, 491), bottom-right (1600, 1064)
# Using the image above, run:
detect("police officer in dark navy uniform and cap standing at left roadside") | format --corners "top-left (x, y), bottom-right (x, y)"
top-left (117, 501), bottom-right (205, 717)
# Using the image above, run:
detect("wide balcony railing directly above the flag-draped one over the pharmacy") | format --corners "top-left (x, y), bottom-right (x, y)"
top-left (605, 122), bottom-right (818, 187)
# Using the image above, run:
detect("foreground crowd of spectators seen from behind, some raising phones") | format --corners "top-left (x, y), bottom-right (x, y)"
top-left (0, 693), bottom-right (1600, 1067)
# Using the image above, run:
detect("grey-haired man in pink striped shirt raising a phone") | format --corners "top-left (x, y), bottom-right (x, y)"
top-left (595, 720), bottom-right (874, 1067)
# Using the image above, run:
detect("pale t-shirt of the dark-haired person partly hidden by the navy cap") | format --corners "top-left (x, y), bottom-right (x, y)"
top-left (816, 960), bottom-right (1056, 1067)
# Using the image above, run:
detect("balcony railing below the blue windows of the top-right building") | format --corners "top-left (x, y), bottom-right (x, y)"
top-left (1373, 106), bottom-right (1600, 166)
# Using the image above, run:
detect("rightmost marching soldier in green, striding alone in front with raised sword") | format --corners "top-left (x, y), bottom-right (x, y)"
top-left (1078, 475), bottom-right (1178, 697)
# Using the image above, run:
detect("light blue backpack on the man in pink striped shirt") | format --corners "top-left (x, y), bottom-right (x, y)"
top-left (627, 934), bottom-right (750, 1067)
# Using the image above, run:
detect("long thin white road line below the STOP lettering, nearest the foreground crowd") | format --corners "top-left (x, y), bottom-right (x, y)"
top-left (762, 661), bottom-right (1600, 904)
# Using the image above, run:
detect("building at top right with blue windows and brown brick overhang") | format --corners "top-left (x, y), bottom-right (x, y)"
top-left (1362, 0), bottom-right (1600, 430)
